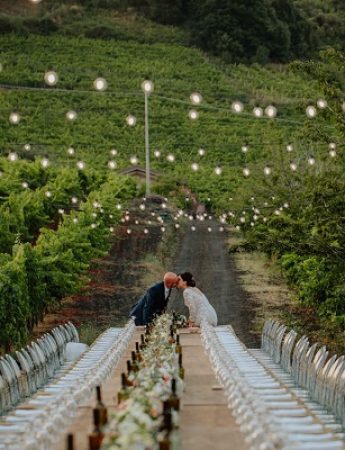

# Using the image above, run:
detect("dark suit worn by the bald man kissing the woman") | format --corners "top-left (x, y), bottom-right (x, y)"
top-left (129, 281), bottom-right (171, 325)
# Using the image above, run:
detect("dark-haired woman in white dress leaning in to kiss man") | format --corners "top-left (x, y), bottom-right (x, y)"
top-left (177, 272), bottom-right (217, 327)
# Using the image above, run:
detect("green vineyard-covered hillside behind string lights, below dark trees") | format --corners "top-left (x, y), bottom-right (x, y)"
top-left (0, 36), bottom-right (318, 211)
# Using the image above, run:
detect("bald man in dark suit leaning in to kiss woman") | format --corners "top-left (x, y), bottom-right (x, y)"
top-left (129, 272), bottom-right (178, 326)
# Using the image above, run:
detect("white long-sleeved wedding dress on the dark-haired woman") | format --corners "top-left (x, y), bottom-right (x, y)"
top-left (183, 287), bottom-right (218, 327)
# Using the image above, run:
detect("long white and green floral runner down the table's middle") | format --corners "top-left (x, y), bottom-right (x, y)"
top-left (102, 314), bottom-right (183, 450)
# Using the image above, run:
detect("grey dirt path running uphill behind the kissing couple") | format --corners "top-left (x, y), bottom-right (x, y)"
top-left (170, 220), bottom-right (259, 347)
